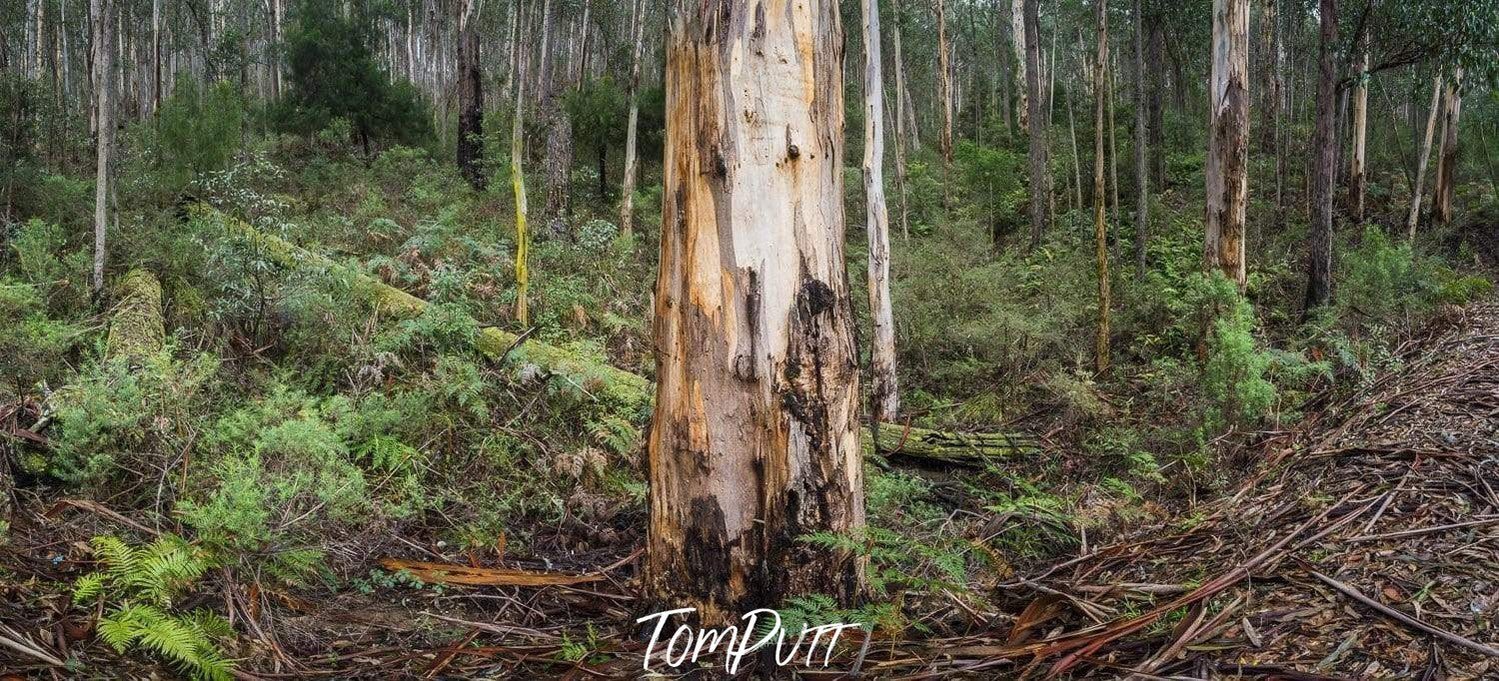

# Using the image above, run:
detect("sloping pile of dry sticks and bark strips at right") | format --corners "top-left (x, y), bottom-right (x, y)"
top-left (866, 306), bottom-right (1499, 680)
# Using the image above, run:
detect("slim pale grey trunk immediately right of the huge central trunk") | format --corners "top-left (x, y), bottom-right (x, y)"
top-left (859, 0), bottom-right (901, 422)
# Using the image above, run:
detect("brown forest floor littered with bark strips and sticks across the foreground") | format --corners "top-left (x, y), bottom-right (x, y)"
top-left (0, 303), bottom-right (1499, 680)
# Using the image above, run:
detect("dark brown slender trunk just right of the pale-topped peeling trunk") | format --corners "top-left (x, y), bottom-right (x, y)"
top-left (1306, 0), bottom-right (1337, 311)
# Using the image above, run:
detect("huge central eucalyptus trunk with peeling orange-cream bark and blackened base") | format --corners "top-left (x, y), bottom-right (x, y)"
top-left (645, 0), bottom-right (865, 626)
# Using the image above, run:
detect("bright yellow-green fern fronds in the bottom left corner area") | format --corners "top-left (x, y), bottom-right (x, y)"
top-left (73, 534), bottom-right (234, 681)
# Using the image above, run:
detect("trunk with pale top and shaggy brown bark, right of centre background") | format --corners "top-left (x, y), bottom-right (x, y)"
top-left (1204, 0), bottom-right (1249, 291)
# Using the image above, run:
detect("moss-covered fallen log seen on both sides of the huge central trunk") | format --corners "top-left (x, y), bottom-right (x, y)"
top-left (202, 204), bottom-right (1040, 465)
